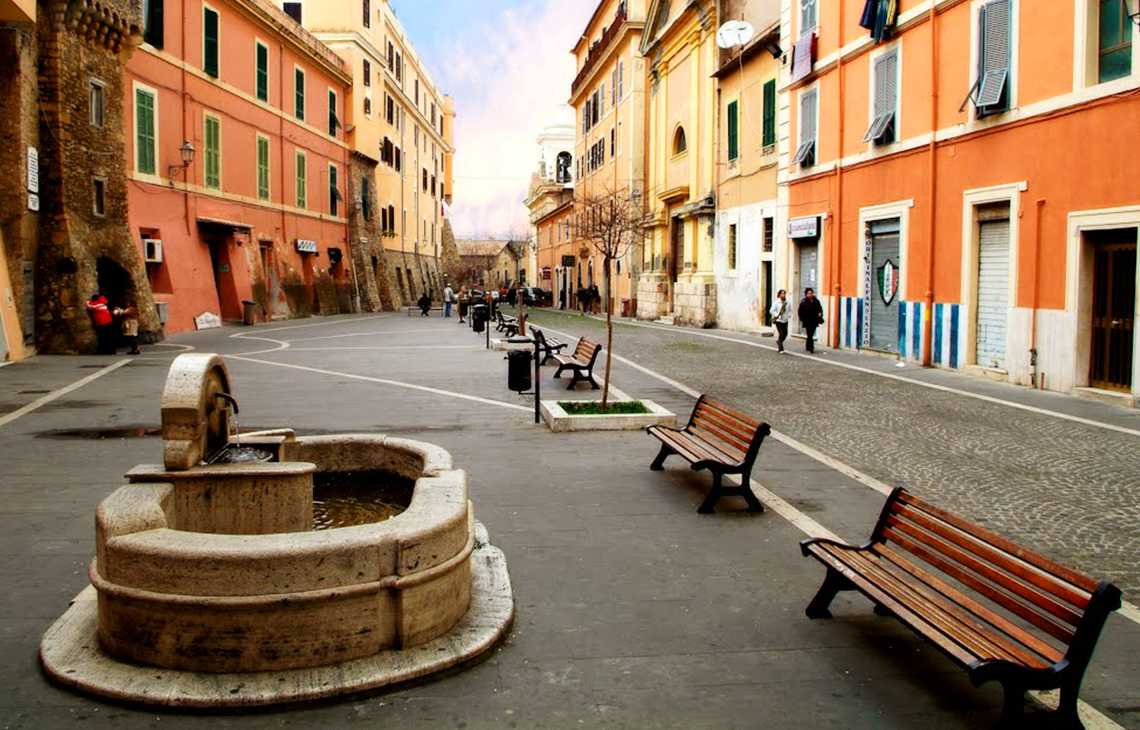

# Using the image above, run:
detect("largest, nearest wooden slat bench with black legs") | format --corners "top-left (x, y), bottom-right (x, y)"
top-left (800, 488), bottom-right (1121, 728)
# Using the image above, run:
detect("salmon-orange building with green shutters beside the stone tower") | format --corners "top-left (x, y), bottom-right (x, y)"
top-left (123, 0), bottom-right (355, 332)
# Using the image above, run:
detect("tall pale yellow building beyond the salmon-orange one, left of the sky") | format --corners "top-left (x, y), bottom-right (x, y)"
top-left (291, 0), bottom-right (455, 302)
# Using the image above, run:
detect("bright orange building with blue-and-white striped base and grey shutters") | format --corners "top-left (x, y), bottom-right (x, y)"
top-left (777, 0), bottom-right (1140, 402)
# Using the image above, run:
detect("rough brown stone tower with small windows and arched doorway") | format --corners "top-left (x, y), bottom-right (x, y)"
top-left (25, 0), bottom-right (162, 354)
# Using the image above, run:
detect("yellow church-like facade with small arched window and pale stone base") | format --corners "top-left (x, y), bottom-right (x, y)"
top-left (637, 0), bottom-right (720, 326)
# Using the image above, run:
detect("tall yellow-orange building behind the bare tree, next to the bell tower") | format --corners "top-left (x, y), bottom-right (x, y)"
top-left (567, 0), bottom-right (646, 313)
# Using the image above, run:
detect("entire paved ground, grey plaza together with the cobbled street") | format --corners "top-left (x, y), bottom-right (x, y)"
top-left (0, 311), bottom-right (1140, 729)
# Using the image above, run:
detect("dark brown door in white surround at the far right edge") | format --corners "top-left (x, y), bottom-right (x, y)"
top-left (1089, 238), bottom-right (1137, 391)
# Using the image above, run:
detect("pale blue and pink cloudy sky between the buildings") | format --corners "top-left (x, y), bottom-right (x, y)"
top-left (389, 0), bottom-right (595, 237)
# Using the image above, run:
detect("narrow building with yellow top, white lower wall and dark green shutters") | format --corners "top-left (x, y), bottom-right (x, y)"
top-left (706, 0), bottom-right (784, 332)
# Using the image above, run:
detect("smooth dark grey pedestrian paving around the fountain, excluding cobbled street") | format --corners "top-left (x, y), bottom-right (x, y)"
top-left (0, 315), bottom-right (1140, 729)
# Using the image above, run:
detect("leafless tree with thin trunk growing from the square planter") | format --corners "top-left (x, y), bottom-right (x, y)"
top-left (571, 182), bottom-right (652, 411)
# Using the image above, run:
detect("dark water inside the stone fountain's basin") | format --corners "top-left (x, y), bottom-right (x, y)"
top-left (312, 471), bottom-right (416, 529)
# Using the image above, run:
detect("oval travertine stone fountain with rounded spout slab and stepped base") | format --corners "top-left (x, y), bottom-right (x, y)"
top-left (40, 354), bottom-right (514, 707)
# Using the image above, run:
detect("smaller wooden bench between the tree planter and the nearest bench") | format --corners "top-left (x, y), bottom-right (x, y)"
top-left (646, 395), bottom-right (772, 514)
